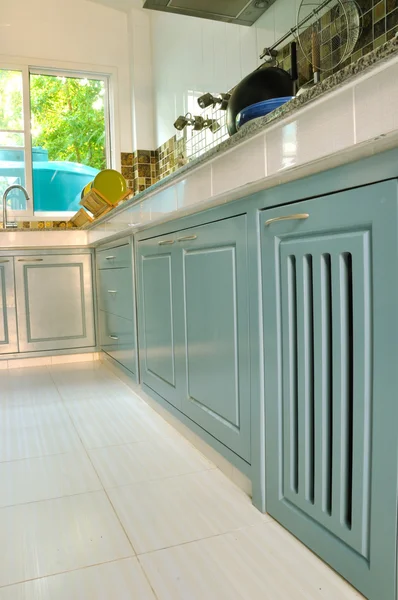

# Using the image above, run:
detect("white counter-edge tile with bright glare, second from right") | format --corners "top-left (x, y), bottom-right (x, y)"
top-left (266, 89), bottom-right (354, 175)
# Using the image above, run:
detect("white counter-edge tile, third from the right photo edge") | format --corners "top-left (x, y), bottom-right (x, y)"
top-left (213, 135), bottom-right (266, 196)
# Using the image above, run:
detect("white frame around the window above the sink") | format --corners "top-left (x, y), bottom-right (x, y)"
top-left (0, 55), bottom-right (121, 220)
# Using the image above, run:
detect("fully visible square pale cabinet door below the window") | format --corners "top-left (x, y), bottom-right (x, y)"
top-left (15, 254), bottom-right (95, 352)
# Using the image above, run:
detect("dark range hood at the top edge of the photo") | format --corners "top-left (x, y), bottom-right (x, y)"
top-left (144, 0), bottom-right (275, 27)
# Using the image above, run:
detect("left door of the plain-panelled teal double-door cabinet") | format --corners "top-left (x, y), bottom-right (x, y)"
top-left (137, 236), bottom-right (182, 407)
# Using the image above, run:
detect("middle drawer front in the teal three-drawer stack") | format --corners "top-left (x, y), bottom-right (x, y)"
top-left (98, 268), bottom-right (134, 320)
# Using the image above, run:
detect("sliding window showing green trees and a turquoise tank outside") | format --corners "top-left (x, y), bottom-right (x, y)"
top-left (0, 68), bottom-right (111, 216)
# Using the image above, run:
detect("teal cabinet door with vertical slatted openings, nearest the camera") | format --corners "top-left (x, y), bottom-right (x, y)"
top-left (260, 181), bottom-right (398, 600)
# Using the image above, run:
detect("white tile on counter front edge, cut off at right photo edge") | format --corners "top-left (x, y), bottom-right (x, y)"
top-left (354, 61), bottom-right (398, 143)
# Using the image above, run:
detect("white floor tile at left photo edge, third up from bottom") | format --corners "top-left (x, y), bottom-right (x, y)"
top-left (0, 451), bottom-right (102, 508)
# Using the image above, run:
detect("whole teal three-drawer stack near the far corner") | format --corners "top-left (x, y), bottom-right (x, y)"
top-left (97, 238), bottom-right (138, 378)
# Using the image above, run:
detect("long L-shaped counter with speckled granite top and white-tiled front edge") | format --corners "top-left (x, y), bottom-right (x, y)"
top-left (0, 38), bottom-right (398, 248)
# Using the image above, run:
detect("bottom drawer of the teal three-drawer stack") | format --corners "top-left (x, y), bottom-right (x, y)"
top-left (100, 310), bottom-right (136, 373)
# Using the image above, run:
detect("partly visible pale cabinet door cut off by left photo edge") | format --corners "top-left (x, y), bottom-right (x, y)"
top-left (0, 257), bottom-right (18, 354)
